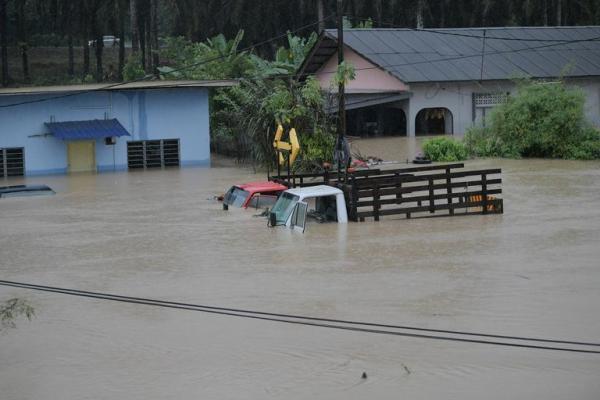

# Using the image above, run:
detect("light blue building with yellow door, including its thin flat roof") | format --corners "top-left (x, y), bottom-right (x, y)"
top-left (0, 81), bottom-right (236, 177)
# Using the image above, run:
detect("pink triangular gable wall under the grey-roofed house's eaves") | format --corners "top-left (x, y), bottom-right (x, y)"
top-left (316, 47), bottom-right (409, 93)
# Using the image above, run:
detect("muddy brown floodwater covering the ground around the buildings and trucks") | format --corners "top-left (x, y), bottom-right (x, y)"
top-left (0, 138), bottom-right (600, 400)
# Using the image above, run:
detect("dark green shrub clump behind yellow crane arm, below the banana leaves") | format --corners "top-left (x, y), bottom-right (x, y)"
top-left (212, 77), bottom-right (334, 168)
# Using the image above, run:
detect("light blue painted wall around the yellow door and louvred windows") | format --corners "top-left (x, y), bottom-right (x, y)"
top-left (0, 88), bottom-right (210, 175)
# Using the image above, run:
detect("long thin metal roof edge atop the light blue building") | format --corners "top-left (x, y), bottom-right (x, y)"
top-left (0, 79), bottom-right (239, 96)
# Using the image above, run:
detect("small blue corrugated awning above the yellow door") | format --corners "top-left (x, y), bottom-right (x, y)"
top-left (46, 119), bottom-right (131, 140)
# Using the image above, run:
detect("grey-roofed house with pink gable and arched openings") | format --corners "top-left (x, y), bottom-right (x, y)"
top-left (299, 26), bottom-right (600, 136)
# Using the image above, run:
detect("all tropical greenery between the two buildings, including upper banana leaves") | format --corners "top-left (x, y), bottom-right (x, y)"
top-left (159, 31), bottom-right (336, 166)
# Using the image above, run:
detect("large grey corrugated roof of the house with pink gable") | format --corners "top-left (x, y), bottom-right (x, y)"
top-left (322, 26), bottom-right (600, 83)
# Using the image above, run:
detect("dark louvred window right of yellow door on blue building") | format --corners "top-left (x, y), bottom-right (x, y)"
top-left (127, 139), bottom-right (179, 168)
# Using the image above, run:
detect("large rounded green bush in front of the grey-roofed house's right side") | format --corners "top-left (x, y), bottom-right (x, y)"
top-left (465, 81), bottom-right (600, 159)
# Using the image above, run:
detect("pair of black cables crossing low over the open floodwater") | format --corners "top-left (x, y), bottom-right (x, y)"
top-left (0, 280), bottom-right (600, 354)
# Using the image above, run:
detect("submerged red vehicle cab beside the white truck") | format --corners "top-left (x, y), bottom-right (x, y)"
top-left (223, 181), bottom-right (287, 210)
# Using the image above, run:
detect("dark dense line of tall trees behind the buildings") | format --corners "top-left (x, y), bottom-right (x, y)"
top-left (0, 0), bottom-right (600, 85)
